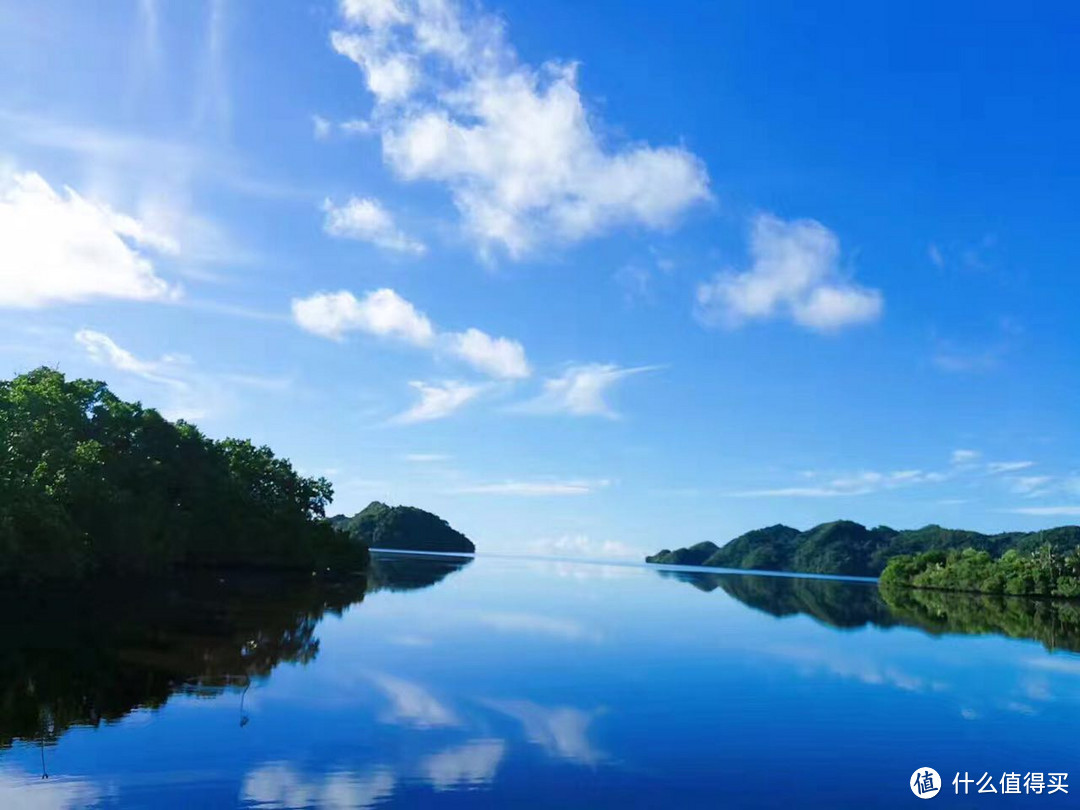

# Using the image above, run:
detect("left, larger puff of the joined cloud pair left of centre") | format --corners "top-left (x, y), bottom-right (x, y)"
top-left (293, 287), bottom-right (435, 347)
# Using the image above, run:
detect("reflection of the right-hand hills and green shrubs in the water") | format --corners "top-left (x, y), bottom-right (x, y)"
top-left (660, 570), bottom-right (1080, 652)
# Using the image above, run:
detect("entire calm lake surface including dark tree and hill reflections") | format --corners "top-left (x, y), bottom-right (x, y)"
top-left (0, 555), bottom-right (1080, 809)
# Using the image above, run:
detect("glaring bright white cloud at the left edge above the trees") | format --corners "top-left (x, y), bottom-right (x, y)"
top-left (0, 172), bottom-right (179, 308)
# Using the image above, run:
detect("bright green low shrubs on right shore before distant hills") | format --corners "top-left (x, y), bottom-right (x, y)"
top-left (880, 544), bottom-right (1080, 597)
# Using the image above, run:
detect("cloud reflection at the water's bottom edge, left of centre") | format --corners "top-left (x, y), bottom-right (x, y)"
top-left (241, 762), bottom-right (396, 810)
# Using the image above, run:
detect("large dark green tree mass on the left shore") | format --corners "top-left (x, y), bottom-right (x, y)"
top-left (0, 368), bottom-right (367, 580)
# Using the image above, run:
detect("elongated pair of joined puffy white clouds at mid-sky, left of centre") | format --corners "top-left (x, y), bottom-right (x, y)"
top-left (293, 288), bottom-right (532, 380)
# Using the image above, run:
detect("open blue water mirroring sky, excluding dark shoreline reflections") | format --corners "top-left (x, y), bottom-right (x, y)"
top-left (0, 555), bottom-right (1080, 809)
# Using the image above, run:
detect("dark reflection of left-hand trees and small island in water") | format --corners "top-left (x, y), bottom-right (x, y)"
top-left (0, 554), bottom-right (471, 750)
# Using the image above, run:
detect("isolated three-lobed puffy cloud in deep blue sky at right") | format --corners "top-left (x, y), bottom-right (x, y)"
top-left (697, 214), bottom-right (883, 332)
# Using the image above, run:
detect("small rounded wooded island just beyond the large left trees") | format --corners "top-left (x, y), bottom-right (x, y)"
top-left (329, 501), bottom-right (476, 554)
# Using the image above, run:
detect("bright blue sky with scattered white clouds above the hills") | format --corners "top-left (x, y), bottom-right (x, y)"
top-left (0, 0), bottom-right (1080, 558)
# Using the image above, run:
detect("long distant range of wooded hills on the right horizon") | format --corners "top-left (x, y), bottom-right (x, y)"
top-left (645, 521), bottom-right (1080, 577)
